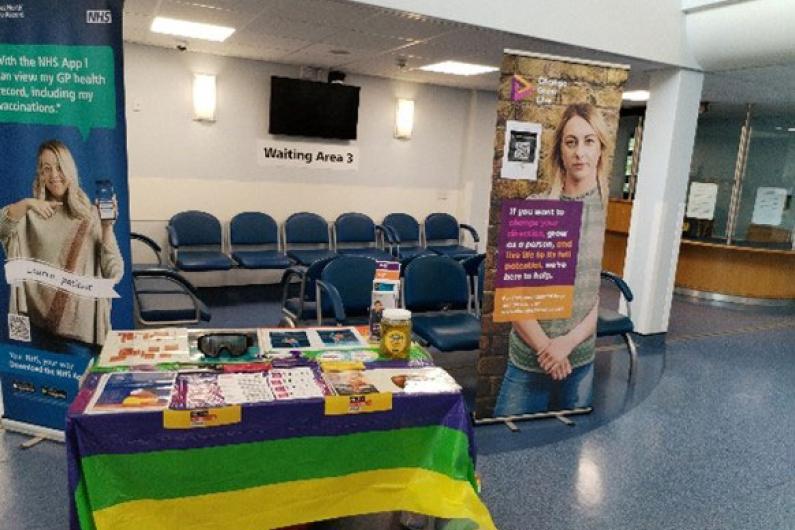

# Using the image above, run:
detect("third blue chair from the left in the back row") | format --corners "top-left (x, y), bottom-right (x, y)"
top-left (282, 212), bottom-right (337, 266)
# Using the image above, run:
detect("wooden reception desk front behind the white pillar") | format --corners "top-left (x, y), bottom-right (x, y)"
top-left (602, 199), bottom-right (795, 304)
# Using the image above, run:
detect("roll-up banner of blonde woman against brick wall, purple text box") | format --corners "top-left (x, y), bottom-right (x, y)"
top-left (476, 50), bottom-right (629, 419)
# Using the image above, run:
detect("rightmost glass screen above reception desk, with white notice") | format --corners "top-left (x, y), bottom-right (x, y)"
top-left (734, 107), bottom-right (795, 248)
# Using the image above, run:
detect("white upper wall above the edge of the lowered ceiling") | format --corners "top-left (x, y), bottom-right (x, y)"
top-left (356, 0), bottom-right (696, 68)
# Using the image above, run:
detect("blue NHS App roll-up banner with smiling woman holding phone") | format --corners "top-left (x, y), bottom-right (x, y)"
top-left (0, 0), bottom-right (133, 435)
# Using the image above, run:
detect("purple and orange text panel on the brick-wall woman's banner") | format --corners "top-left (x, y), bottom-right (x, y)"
top-left (494, 199), bottom-right (582, 322)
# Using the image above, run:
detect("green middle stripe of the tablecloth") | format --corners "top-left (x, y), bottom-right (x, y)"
top-left (81, 426), bottom-right (475, 511)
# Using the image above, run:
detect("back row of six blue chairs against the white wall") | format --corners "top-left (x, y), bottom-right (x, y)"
top-left (166, 210), bottom-right (480, 271)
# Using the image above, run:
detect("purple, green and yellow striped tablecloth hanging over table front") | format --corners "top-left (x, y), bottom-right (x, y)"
top-left (66, 375), bottom-right (495, 530)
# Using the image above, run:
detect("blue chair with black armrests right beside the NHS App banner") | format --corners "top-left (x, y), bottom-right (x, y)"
top-left (130, 232), bottom-right (211, 326)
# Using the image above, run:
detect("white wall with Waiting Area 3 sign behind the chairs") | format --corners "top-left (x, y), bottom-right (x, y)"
top-left (124, 43), bottom-right (496, 280)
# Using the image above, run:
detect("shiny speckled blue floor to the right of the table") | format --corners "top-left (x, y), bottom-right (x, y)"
top-left (477, 323), bottom-right (795, 530)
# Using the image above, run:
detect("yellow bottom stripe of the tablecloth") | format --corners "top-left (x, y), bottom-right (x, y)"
top-left (94, 468), bottom-right (496, 530)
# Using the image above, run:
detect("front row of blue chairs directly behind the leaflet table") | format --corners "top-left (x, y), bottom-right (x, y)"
top-left (282, 254), bottom-right (485, 352)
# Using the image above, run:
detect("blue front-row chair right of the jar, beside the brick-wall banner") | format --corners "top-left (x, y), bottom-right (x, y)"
top-left (403, 256), bottom-right (481, 352)
